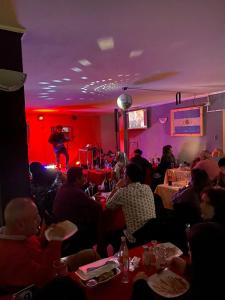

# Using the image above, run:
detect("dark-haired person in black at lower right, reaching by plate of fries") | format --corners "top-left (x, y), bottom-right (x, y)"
top-left (132, 188), bottom-right (225, 300)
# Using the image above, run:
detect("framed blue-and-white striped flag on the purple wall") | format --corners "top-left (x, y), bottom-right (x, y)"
top-left (170, 106), bottom-right (203, 136)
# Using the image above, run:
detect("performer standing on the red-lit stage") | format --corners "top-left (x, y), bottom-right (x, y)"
top-left (48, 125), bottom-right (69, 169)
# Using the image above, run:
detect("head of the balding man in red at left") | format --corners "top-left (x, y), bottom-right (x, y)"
top-left (4, 197), bottom-right (41, 237)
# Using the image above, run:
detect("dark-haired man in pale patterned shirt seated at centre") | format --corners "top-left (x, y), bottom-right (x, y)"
top-left (106, 163), bottom-right (156, 251)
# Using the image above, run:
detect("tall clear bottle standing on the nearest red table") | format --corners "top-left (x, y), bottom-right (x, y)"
top-left (119, 236), bottom-right (129, 283)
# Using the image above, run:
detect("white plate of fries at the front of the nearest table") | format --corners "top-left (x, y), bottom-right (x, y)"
top-left (148, 269), bottom-right (190, 298)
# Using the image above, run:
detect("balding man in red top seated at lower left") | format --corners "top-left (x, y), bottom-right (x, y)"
top-left (0, 198), bottom-right (94, 299)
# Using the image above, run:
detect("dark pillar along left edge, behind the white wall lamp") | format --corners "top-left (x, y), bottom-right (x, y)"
top-left (0, 29), bottom-right (29, 223)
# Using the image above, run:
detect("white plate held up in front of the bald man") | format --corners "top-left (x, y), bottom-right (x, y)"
top-left (45, 220), bottom-right (78, 241)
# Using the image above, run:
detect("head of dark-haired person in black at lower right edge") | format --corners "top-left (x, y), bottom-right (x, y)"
top-left (200, 188), bottom-right (225, 224)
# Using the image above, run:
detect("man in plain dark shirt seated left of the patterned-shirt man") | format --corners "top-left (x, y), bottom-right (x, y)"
top-left (53, 167), bottom-right (102, 255)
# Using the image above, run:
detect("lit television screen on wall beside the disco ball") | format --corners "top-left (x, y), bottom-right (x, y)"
top-left (127, 109), bottom-right (148, 129)
